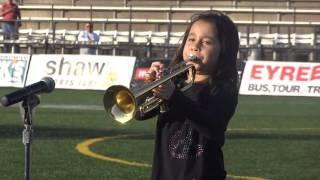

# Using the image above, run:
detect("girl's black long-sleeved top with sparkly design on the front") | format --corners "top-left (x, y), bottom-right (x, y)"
top-left (136, 83), bottom-right (237, 180)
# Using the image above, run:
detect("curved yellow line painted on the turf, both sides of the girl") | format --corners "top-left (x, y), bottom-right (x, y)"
top-left (76, 134), bottom-right (267, 180)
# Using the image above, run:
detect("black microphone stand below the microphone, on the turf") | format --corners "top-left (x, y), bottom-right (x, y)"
top-left (22, 94), bottom-right (40, 180)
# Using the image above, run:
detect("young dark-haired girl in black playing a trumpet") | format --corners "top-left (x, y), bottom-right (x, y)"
top-left (136, 11), bottom-right (239, 180)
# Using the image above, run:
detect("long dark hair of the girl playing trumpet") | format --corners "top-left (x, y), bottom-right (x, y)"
top-left (172, 11), bottom-right (239, 93)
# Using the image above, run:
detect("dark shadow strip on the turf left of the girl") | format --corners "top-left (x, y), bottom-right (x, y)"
top-left (0, 125), bottom-right (153, 139)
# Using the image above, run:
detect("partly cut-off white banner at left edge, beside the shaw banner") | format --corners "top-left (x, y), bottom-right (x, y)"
top-left (0, 54), bottom-right (30, 87)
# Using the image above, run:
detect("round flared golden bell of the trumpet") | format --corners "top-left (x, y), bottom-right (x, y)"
top-left (103, 85), bottom-right (137, 124)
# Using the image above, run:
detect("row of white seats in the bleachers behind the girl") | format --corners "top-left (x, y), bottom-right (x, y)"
top-left (3, 29), bottom-right (320, 60)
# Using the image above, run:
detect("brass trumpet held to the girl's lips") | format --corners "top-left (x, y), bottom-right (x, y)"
top-left (103, 62), bottom-right (195, 123)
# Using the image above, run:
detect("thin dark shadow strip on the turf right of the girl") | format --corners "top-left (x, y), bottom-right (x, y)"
top-left (226, 132), bottom-right (320, 140)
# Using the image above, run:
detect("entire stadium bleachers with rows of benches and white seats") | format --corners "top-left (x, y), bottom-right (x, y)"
top-left (0, 0), bottom-right (320, 61)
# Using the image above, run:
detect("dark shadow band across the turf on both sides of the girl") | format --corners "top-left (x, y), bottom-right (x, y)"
top-left (0, 125), bottom-right (320, 140)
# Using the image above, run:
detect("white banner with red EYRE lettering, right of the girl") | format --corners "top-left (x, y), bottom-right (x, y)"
top-left (240, 61), bottom-right (320, 97)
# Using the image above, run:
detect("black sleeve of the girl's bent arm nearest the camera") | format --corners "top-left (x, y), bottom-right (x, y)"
top-left (169, 89), bottom-right (237, 138)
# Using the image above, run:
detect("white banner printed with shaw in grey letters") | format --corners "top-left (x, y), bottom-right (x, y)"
top-left (27, 54), bottom-right (135, 90)
